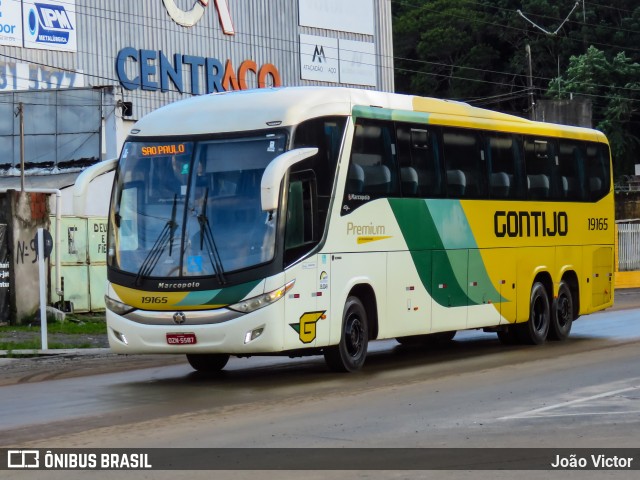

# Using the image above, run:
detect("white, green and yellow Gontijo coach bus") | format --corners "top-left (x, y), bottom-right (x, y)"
top-left (106, 87), bottom-right (614, 371)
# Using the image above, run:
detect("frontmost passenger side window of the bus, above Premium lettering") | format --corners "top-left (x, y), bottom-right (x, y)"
top-left (347, 121), bottom-right (399, 198)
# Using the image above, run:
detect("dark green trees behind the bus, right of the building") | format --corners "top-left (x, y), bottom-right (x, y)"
top-left (392, 0), bottom-right (640, 173)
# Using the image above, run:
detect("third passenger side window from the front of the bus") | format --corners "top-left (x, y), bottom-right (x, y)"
top-left (442, 129), bottom-right (486, 198)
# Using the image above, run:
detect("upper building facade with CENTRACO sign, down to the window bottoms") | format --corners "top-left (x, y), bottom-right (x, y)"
top-left (0, 0), bottom-right (394, 178)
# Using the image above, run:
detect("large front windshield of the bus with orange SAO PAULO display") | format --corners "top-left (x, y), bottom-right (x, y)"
top-left (108, 132), bottom-right (286, 283)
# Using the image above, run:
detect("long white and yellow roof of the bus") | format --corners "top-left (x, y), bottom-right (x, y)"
top-left (127, 86), bottom-right (607, 142)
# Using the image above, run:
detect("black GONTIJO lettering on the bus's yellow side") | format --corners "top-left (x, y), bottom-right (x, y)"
top-left (493, 210), bottom-right (569, 237)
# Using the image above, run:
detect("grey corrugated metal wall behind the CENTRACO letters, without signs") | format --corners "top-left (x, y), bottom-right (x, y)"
top-left (71, 0), bottom-right (394, 118)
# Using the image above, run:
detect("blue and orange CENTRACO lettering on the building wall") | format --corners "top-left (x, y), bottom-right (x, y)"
top-left (116, 47), bottom-right (282, 95)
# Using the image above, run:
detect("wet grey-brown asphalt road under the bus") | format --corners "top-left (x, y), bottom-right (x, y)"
top-left (0, 293), bottom-right (640, 478)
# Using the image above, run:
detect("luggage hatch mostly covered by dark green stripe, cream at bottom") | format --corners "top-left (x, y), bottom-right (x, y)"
top-left (431, 249), bottom-right (469, 332)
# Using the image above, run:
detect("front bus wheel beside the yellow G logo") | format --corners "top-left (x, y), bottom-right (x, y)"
top-left (324, 297), bottom-right (369, 372)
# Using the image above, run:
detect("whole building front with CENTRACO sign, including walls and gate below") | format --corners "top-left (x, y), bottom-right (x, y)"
top-left (0, 0), bottom-right (394, 323)
